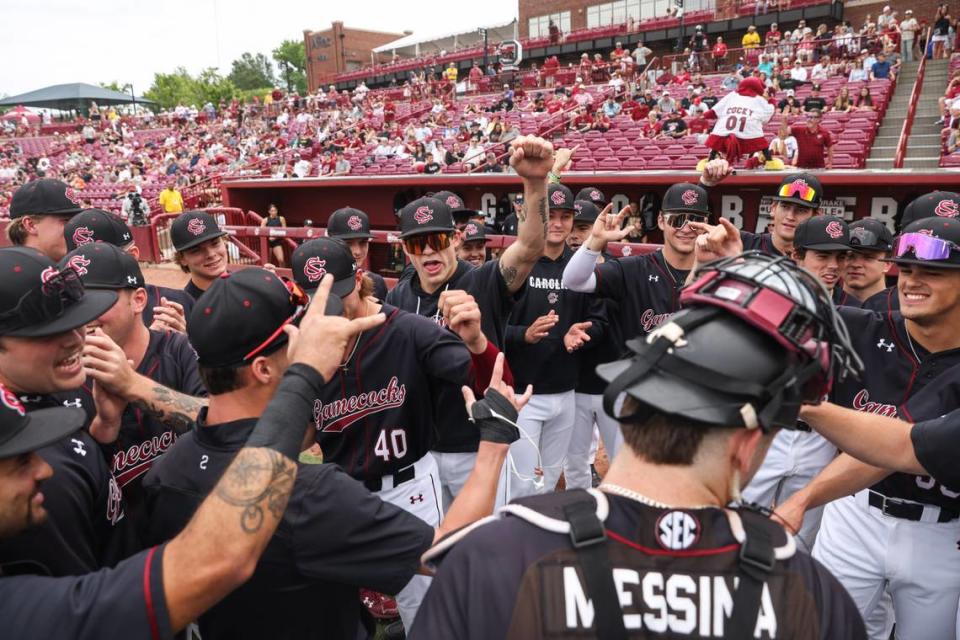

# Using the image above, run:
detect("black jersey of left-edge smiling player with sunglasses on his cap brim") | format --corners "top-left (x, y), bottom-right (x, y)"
top-left (0, 389), bottom-right (133, 576)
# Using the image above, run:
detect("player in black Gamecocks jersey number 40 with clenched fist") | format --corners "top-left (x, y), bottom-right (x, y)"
top-left (291, 239), bottom-right (512, 629)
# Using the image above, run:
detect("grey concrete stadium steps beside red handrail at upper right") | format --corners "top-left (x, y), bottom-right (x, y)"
top-left (867, 60), bottom-right (949, 169)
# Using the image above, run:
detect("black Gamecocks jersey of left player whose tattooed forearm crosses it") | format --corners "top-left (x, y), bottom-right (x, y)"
top-left (105, 331), bottom-right (207, 506)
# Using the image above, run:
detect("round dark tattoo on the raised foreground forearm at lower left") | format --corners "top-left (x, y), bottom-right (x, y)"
top-left (214, 448), bottom-right (297, 533)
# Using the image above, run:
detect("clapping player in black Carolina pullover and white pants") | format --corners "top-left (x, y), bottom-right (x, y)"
top-left (503, 184), bottom-right (607, 504)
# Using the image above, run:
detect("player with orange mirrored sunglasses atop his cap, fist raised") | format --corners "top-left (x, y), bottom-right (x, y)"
top-left (700, 159), bottom-right (823, 256)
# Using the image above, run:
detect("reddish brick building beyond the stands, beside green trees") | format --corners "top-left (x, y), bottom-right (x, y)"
top-left (303, 22), bottom-right (410, 92)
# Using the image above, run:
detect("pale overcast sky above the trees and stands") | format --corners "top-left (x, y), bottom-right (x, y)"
top-left (0, 0), bottom-right (517, 95)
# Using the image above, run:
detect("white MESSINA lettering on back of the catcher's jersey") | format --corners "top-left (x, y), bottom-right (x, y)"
top-left (562, 567), bottom-right (778, 638)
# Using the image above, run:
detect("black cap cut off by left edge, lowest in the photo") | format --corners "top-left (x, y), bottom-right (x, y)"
top-left (0, 385), bottom-right (87, 459)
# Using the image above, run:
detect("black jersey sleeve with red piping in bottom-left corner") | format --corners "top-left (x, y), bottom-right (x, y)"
top-left (0, 547), bottom-right (174, 640)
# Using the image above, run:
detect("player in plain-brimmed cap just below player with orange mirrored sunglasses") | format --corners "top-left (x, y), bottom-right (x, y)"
top-left (743, 216), bottom-right (850, 552)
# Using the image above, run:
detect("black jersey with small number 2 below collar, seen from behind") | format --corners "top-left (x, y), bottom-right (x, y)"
top-left (144, 411), bottom-right (434, 640)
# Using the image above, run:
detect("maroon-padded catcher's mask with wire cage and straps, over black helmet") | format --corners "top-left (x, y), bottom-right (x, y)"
top-left (604, 251), bottom-right (863, 430)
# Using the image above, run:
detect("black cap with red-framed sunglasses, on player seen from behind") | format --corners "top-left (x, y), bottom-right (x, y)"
top-left (187, 267), bottom-right (309, 368)
